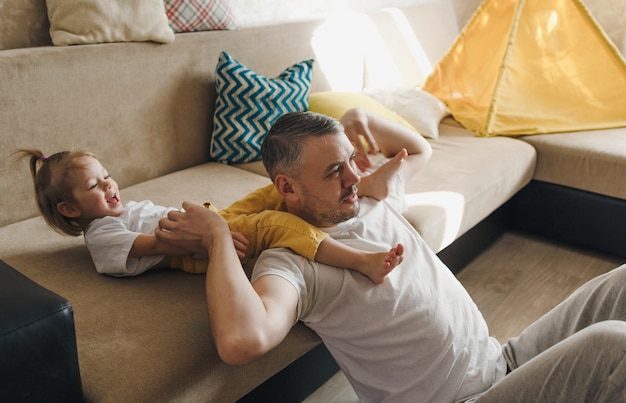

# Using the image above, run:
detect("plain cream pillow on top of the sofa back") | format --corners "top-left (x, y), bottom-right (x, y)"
top-left (46, 0), bottom-right (174, 45)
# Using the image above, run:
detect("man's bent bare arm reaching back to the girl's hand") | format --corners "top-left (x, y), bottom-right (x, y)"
top-left (157, 203), bottom-right (298, 365)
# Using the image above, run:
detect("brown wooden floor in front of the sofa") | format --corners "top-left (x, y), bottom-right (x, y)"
top-left (305, 231), bottom-right (623, 403)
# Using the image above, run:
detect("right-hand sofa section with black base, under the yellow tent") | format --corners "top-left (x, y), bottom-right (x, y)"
top-left (514, 128), bottom-right (626, 258)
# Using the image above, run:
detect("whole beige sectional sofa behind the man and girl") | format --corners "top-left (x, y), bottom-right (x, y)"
top-left (0, 1), bottom-right (626, 402)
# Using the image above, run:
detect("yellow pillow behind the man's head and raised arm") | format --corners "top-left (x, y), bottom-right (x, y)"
top-left (309, 91), bottom-right (419, 133)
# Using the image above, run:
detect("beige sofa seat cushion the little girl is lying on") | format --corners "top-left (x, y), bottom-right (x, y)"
top-left (0, 162), bottom-right (320, 402)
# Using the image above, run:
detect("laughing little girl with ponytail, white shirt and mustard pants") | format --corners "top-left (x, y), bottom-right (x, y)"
top-left (16, 149), bottom-right (403, 283)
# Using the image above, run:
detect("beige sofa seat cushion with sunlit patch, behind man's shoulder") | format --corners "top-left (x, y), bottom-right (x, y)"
top-left (405, 124), bottom-right (535, 252)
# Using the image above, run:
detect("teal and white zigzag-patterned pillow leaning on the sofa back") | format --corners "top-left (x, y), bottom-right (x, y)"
top-left (211, 52), bottom-right (313, 163)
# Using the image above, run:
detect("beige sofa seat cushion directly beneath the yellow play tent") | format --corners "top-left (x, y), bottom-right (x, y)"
top-left (522, 128), bottom-right (626, 199)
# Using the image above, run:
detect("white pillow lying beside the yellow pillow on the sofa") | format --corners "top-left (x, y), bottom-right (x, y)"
top-left (363, 87), bottom-right (450, 139)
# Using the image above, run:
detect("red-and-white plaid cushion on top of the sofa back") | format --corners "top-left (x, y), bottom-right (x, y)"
top-left (164, 0), bottom-right (237, 32)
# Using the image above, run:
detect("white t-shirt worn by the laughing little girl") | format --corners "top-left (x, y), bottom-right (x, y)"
top-left (84, 200), bottom-right (175, 276)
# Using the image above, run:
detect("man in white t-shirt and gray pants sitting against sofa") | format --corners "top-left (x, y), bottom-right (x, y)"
top-left (158, 111), bottom-right (626, 402)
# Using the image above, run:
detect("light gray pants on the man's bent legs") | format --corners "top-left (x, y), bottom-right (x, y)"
top-left (476, 265), bottom-right (626, 403)
